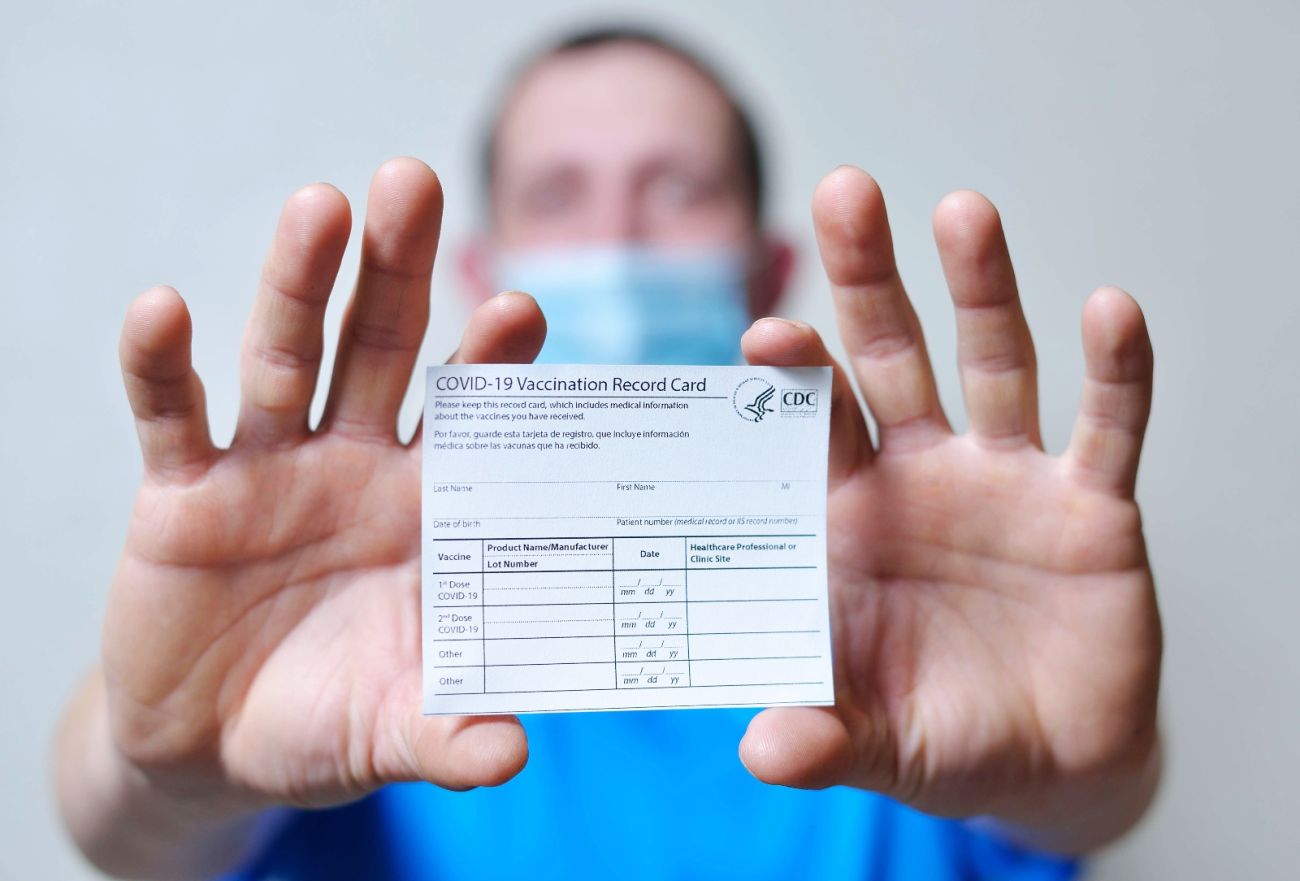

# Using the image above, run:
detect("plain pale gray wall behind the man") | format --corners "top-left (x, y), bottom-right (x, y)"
top-left (0, 0), bottom-right (1300, 878)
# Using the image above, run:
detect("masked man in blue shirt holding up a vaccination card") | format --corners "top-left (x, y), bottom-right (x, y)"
top-left (59, 24), bottom-right (1161, 878)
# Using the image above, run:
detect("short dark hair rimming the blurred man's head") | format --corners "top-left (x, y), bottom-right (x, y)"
top-left (480, 25), bottom-right (764, 221)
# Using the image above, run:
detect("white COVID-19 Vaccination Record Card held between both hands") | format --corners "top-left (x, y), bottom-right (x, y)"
top-left (423, 364), bottom-right (835, 713)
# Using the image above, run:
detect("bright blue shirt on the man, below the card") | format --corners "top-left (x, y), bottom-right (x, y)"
top-left (220, 709), bottom-right (1078, 881)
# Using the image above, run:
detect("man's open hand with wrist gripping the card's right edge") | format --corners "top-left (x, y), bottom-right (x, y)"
top-left (741, 168), bottom-right (1161, 851)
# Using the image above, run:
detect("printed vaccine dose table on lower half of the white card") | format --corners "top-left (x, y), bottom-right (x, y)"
top-left (430, 534), bottom-right (827, 708)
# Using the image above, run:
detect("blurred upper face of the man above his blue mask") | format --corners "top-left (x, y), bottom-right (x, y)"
top-left (489, 43), bottom-right (755, 248)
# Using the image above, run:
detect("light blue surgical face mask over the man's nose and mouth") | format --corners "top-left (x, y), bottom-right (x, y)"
top-left (493, 244), bottom-right (750, 364)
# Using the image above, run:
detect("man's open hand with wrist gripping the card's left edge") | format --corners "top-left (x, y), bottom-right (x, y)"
top-left (60, 159), bottom-right (545, 875)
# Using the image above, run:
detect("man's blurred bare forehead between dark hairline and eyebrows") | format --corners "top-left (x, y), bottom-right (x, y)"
top-left (497, 42), bottom-right (735, 170)
